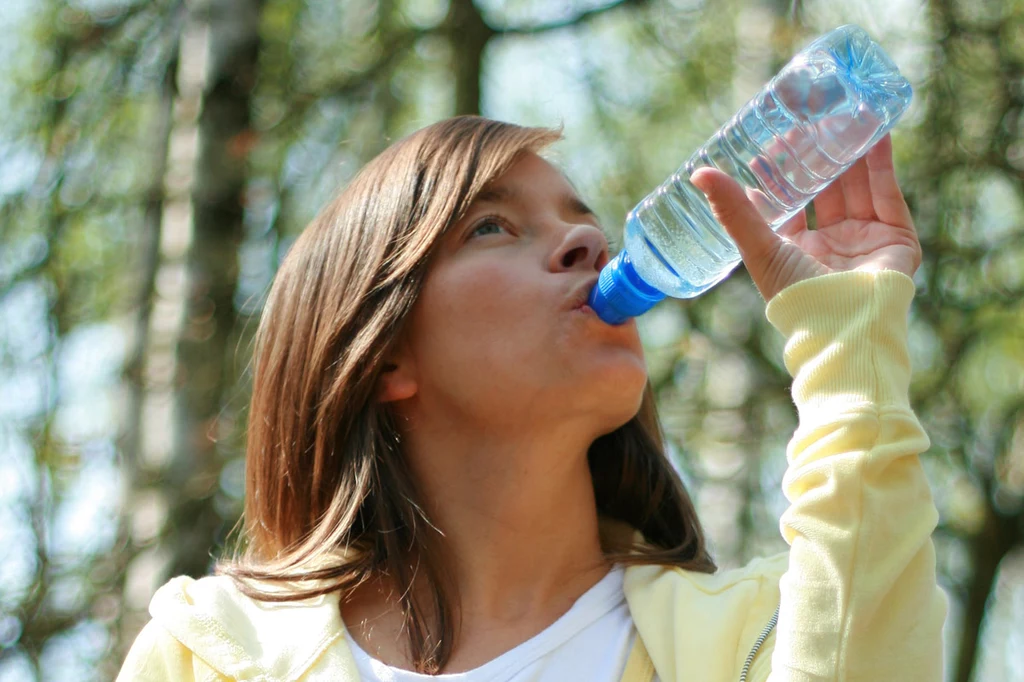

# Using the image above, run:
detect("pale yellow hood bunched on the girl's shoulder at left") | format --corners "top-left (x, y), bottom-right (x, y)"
top-left (150, 576), bottom-right (354, 682)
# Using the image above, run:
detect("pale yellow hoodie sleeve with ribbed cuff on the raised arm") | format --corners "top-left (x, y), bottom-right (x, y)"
top-left (767, 270), bottom-right (946, 682)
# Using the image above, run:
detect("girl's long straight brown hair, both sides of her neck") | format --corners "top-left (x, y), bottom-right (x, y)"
top-left (215, 117), bottom-right (715, 673)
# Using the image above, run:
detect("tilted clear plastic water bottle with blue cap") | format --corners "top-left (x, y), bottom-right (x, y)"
top-left (589, 25), bottom-right (911, 324)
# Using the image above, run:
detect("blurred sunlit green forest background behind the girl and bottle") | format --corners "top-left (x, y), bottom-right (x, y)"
top-left (0, 0), bottom-right (1024, 682)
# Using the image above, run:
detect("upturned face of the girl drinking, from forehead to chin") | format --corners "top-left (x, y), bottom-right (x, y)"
top-left (391, 149), bottom-right (647, 437)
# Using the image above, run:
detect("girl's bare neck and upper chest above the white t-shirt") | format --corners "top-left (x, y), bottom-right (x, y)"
top-left (342, 409), bottom-right (608, 672)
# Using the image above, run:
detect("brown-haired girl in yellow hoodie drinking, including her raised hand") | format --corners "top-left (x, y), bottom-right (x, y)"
top-left (119, 117), bottom-right (946, 682)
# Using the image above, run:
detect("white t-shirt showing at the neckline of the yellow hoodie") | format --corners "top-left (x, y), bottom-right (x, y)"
top-left (345, 566), bottom-right (655, 682)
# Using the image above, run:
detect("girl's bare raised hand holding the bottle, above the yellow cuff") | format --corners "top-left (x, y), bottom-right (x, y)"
top-left (690, 135), bottom-right (921, 300)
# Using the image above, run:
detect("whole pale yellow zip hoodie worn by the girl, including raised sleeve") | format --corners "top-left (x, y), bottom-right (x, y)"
top-left (118, 271), bottom-right (946, 682)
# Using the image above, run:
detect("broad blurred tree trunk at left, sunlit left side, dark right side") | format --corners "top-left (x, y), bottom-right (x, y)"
top-left (122, 0), bottom-right (261, 630)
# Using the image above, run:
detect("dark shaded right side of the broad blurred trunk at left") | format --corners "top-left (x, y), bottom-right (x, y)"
top-left (162, 0), bottom-right (262, 578)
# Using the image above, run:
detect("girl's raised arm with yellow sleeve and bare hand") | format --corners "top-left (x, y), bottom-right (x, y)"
top-left (693, 139), bottom-right (946, 682)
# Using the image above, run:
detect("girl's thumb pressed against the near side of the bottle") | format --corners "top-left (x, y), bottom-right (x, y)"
top-left (690, 168), bottom-right (781, 269)
